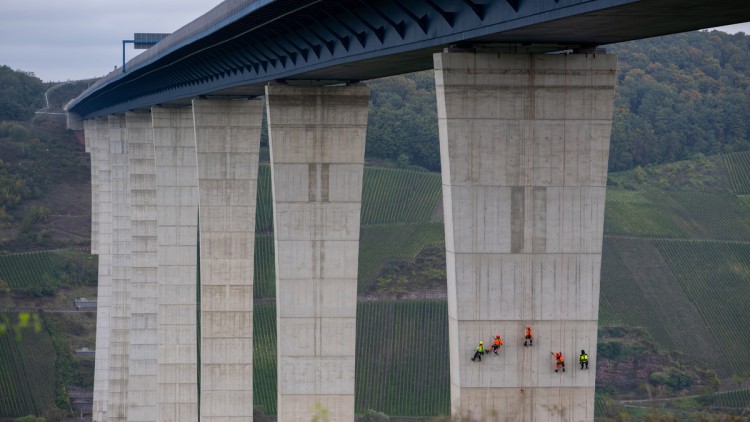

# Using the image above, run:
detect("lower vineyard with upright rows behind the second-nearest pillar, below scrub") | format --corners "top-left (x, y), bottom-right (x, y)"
top-left (253, 302), bottom-right (450, 416)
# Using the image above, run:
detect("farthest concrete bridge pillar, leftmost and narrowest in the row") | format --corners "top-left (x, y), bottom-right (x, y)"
top-left (91, 117), bottom-right (112, 422)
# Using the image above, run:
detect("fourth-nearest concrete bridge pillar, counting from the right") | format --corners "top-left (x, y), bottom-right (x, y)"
top-left (151, 106), bottom-right (198, 422)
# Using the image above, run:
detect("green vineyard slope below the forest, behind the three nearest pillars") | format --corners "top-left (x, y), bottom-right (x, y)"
top-left (245, 149), bottom-right (750, 417)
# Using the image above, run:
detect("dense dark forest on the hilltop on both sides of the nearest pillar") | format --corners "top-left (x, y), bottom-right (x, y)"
top-left (366, 31), bottom-right (750, 171)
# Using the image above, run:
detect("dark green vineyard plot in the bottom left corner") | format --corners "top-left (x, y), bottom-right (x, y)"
top-left (0, 313), bottom-right (55, 417)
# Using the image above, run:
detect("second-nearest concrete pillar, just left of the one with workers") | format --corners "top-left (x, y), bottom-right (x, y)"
top-left (266, 85), bottom-right (369, 422)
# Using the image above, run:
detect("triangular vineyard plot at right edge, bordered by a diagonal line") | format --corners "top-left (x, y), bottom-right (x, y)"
top-left (655, 241), bottom-right (750, 377)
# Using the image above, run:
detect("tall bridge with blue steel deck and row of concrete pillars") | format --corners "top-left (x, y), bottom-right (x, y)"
top-left (67, 0), bottom-right (750, 421)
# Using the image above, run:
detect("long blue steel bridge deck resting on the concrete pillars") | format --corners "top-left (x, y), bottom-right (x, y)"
top-left (68, 0), bottom-right (750, 118)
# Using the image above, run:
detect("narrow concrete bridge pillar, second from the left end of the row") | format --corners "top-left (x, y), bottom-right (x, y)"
top-left (107, 114), bottom-right (131, 422)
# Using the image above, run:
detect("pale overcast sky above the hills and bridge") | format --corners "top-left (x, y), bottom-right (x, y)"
top-left (0, 0), bottom-right (750, 81)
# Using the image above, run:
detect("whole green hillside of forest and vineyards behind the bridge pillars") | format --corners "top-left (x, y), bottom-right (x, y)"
top-left (0, 28), bottom-right (750, 420)
